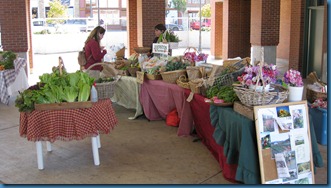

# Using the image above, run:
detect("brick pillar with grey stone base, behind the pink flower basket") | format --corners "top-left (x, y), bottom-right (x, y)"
top-left (250, 0), bottom-right (280, 64)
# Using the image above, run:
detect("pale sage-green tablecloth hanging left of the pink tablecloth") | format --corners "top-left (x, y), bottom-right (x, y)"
top-left (111, 76), bottom-right (143, 119)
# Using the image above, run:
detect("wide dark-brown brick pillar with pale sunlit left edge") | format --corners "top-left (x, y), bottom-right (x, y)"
top-left (222, 0), bottom-right (255, 59)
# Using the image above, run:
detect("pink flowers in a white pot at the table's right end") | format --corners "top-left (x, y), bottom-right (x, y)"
top-left (283, 69), bottom-right (303, 102)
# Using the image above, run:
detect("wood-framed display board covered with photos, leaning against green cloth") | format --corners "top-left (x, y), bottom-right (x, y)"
top-left (254, 101), bottom-right (315, 184)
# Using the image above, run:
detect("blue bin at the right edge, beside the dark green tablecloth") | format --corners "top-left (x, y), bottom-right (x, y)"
top-left (309, 107), bottom-right (328, 145)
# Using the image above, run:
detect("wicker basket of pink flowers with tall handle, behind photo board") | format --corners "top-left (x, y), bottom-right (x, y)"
top-left (233, 48), bottom-right (288, 106)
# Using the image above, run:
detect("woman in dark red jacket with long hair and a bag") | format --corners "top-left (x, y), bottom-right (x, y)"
top-left (84, 26), bottom-right (107, 78)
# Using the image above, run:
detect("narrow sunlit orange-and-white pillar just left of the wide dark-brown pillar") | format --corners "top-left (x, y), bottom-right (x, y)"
top-left (210, 0), bottom-right (223, 59)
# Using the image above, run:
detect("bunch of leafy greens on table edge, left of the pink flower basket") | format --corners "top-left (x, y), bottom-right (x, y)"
top-left (206, 86), bottom-right (239, 103)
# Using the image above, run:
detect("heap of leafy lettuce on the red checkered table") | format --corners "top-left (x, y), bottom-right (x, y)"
top-left (15, 68), bottom-right (94, 112)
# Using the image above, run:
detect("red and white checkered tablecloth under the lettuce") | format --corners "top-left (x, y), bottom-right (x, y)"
top-left (19, 99), bottom-right (118, 142)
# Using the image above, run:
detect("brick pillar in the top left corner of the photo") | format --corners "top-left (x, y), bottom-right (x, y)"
top-left (0, 0), bottom-right (32, 73)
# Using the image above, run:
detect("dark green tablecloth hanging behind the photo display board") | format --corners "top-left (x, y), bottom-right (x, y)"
top-left (210, 105), bottom-right (323, 184)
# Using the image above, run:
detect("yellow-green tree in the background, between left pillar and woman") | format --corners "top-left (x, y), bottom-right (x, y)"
top-left (47, 0), bottom-right (68, 25)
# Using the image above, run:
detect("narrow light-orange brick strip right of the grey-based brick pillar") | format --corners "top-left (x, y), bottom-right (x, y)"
top-left (277, 0), bottom-right (291, 59)
